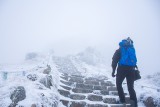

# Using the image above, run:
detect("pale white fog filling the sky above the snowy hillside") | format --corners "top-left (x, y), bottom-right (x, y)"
top-left (0, 0), bottom-right (160, 73)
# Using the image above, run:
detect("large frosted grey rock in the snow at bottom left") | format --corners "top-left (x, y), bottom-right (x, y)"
top-left (9, 86), bottom-right (26, 107)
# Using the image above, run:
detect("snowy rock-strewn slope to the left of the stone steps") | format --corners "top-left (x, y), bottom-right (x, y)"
top-left (0, 56), bottom-right (63, 107)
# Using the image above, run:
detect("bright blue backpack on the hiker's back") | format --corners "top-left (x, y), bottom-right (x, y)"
top-left (119, 40), bottom-right (137, 66)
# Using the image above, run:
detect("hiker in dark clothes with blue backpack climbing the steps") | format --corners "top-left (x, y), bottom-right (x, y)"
top-left (112, 37), bottom-right (138, 107)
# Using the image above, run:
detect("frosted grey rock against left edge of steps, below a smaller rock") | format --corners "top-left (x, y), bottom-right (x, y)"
top-left (40, 75), bottom-right (52, 88)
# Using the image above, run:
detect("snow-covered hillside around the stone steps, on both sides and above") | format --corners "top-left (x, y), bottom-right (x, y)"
top-left (0, 49), bottom-right (160, 107)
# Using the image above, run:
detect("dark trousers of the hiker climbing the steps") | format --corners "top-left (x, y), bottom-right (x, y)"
top-left (116, 66), bottom-right (137, 107)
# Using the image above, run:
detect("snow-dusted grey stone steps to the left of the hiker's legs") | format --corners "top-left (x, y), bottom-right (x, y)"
top-left (58, 73), bottom-right (130, 107)
